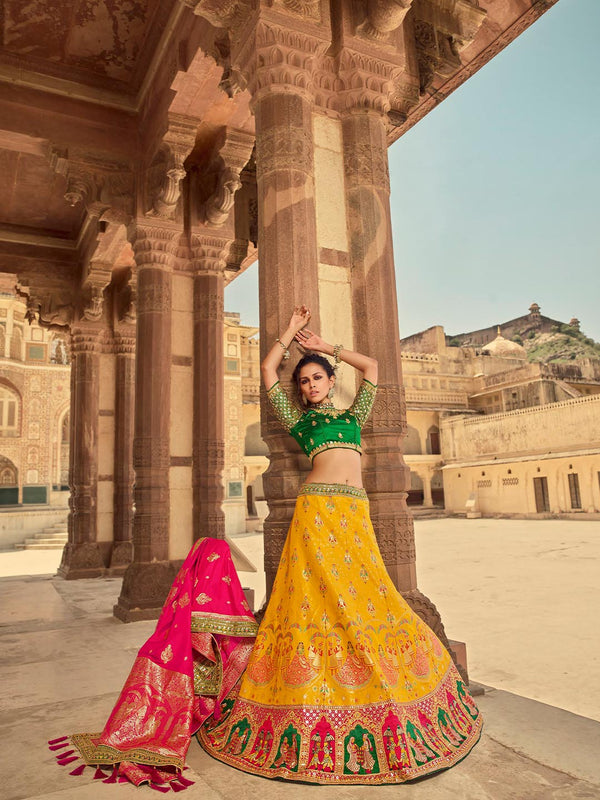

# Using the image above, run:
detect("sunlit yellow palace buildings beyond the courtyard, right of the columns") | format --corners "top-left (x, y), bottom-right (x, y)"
top-left (401, 303), bottom-right (600, 515)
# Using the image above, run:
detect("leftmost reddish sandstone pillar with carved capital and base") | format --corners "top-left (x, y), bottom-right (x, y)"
top-left (58, 322), bottom-right (105, 579)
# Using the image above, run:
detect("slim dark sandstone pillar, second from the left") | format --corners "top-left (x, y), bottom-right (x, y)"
top-left (110, 326), bottom-right (135, 572)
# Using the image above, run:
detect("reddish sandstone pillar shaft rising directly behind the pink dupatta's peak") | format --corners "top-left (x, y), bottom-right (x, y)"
top-left (192, 262), bottom-right (225, 540)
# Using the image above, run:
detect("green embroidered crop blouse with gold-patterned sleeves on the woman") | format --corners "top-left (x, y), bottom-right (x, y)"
top-left (267, 378), bottom-right (377, 459)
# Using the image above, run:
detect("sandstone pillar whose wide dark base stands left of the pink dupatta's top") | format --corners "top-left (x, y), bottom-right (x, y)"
top-left (114, 224), bottom-right (177, 622)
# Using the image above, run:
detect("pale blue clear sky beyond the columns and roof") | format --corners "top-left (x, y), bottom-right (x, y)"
top-left (225, 0), bottom-right (600, 341)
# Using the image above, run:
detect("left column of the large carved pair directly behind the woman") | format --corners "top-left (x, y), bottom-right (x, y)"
top-left (234, 15), bottom-right (329, 593)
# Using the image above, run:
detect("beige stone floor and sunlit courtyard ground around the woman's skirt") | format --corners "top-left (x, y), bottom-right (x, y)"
top-left (0, 519), bottom-right (600, 800)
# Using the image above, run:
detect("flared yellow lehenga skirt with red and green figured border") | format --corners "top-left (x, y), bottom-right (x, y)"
top-left (197, 484), bottom-right (482, 784)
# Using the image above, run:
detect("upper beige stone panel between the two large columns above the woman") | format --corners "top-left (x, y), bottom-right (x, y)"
top-left (313, 114), bottom-right (348, 252)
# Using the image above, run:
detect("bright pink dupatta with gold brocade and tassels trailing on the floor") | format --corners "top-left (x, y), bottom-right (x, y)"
top-left (50, 539), bottom-right (258, 791)
